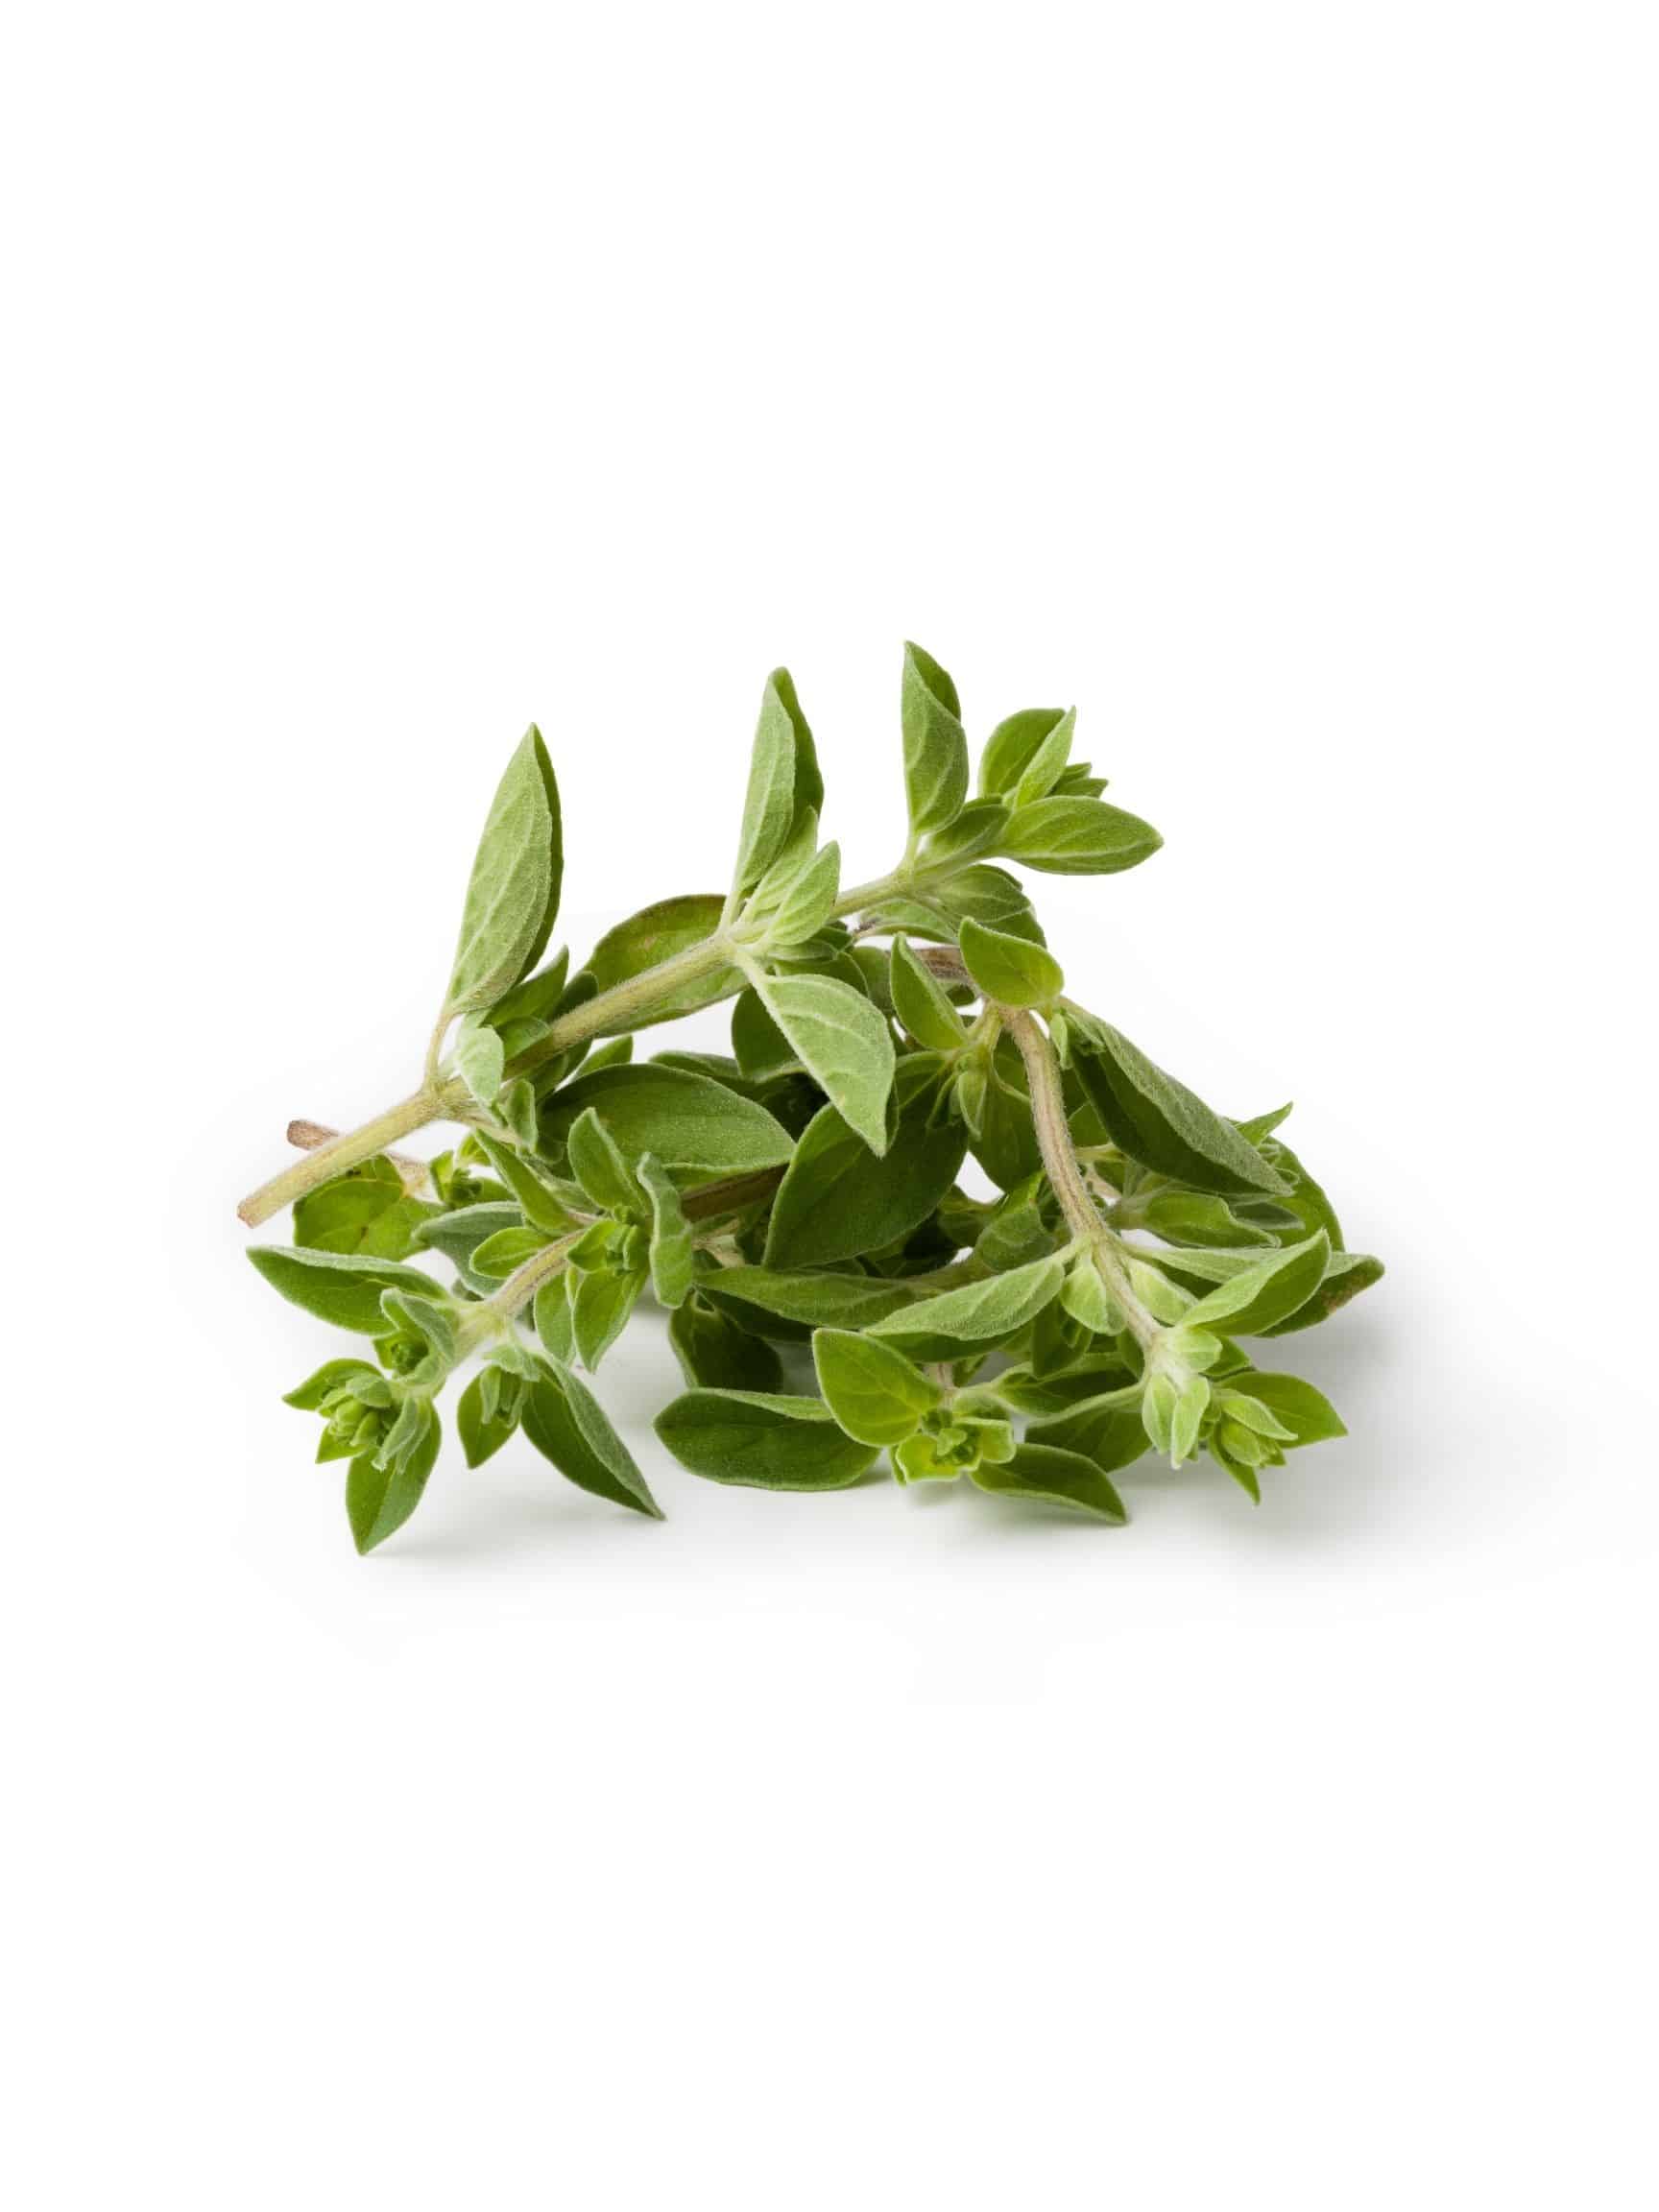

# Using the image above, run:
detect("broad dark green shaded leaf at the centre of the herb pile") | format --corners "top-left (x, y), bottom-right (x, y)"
top-left (765, 1055), bottom-right (967, 1267)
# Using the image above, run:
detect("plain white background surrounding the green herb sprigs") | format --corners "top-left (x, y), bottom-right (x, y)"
top-left (0, 0), bottom-right (1659, 2212)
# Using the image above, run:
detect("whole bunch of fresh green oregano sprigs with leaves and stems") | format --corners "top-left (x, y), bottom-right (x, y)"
top-left (241, 646), bottom-right (1382, 1551)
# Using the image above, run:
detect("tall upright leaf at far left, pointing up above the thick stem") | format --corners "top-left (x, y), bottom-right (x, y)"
top-left (445, 723), bottom-right (565, 1013)
